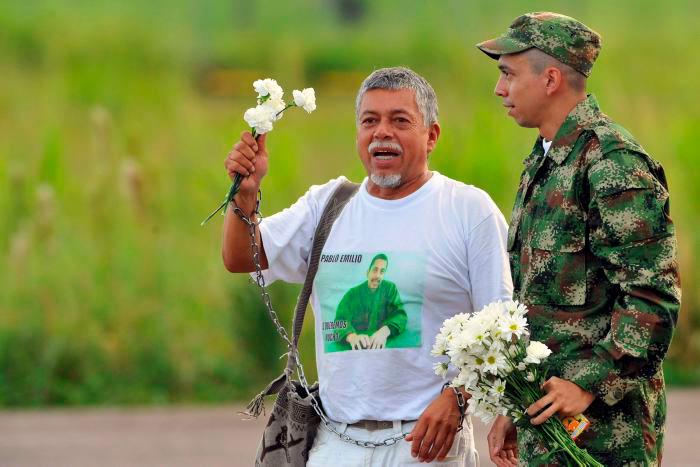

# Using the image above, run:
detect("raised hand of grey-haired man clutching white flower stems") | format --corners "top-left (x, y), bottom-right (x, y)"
top-left (224, 131), bottom-right (268, 199)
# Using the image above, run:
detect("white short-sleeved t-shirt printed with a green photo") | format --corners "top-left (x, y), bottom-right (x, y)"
top-left (260, 172), bottom-right (512, 423)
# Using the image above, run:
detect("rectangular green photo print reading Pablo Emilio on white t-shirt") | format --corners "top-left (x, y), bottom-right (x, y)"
top-left (314, 251), bottom-right (425, 352)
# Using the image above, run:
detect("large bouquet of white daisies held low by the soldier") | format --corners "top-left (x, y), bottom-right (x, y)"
top-left (432, 301), bottom-right (602, 466)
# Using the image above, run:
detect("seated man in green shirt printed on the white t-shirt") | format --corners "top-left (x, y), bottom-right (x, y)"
top-left (335, 253), bottom-right (408, 350)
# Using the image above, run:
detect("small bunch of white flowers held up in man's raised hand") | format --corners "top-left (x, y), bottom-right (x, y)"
top-left (202, 78), bottom-right (316, 225)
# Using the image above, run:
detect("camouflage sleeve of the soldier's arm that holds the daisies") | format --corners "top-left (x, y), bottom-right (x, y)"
top-left (572, 150), bottom-right (680, 405)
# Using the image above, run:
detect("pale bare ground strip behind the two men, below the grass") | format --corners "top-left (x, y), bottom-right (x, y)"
top-left (0, 390), bottom-right (700, 467)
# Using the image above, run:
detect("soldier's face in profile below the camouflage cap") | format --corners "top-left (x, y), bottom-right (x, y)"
top-left (494, 53), bottom-right (547, 128)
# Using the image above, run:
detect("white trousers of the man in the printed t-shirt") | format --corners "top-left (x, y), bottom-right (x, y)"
top-left (306, 417), bottom-right (479, 467)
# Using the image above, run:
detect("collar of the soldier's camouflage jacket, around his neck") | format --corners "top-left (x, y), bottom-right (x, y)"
top-left (536, 94), bottom-right (601, 164)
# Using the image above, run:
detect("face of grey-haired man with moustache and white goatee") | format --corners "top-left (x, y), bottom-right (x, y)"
top-left (357, 89), bottom-right (439, 193)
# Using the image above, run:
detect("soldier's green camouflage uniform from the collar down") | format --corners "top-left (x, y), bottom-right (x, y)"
top-left (508, 95), bottom-right (680, 465)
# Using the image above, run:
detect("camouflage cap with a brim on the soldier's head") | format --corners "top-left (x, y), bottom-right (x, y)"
top-left (476, 12), bottom-right (600, 76)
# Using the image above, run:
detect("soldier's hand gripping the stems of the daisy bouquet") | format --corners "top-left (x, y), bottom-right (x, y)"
top-left (527, 376), bottom-right (595, 425)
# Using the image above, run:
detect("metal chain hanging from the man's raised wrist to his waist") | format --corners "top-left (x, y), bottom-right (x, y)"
top-left (231, 190), bottom-right (408, 448)
